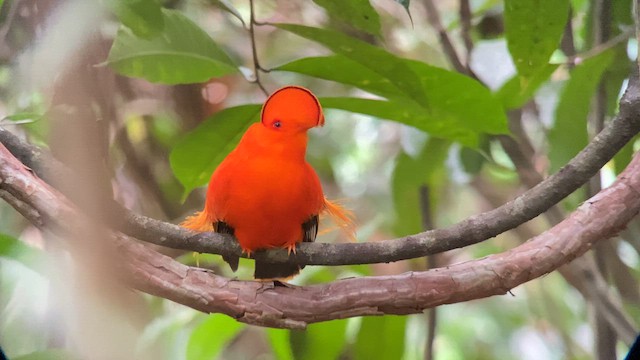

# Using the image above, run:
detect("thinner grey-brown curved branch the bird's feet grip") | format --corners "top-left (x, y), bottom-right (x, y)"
top-left (0, 76), bottom-right (640, 265)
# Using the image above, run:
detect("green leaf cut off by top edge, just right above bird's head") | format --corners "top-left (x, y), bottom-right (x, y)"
top-left (313, 0), bottom-right (380, 36)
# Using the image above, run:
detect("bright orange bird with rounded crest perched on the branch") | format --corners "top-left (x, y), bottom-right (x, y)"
top-left (181, 86), bottom-right (353, 279)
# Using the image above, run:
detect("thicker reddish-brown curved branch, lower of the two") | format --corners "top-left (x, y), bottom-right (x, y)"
top-left (0, 141), bottom-right (640, 332)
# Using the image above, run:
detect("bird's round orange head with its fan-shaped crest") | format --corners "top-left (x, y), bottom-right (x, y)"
top-left (261, 86), bottom-right (324, 133)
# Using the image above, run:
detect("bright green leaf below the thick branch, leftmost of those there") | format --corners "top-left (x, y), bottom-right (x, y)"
top-left (187, 314), bottom-right (244, 360)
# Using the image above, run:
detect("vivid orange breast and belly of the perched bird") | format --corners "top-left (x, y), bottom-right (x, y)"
top-left (207, 156), bottom-right (324, 250)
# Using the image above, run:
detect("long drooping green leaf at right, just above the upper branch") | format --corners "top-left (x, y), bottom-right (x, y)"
top-left (549, 50), bottom-right (615, 172)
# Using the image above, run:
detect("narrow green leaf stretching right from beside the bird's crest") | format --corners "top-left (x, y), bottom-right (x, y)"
top-left (320, 97), bottom-right (478, 147)
